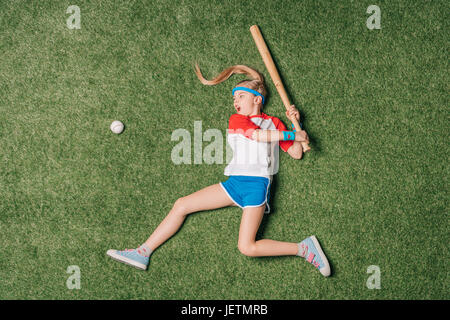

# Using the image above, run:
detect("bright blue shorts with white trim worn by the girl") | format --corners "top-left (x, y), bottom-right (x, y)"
top-left (220, 176), bottom-right (271, 213)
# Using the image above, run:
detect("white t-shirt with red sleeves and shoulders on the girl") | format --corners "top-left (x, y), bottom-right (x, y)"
top-left (224, 113), bottom-right (293, 179)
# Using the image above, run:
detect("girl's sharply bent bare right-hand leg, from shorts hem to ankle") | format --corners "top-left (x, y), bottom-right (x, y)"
top-left (238, 205), bottom-right (298, 257)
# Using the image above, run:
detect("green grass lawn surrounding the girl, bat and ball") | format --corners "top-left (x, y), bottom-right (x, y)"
top-left (0, 0), bottom-right (450, 300)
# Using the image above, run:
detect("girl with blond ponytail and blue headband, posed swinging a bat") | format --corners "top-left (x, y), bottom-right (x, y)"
top-left (107, 65), bottom-right (330, 277)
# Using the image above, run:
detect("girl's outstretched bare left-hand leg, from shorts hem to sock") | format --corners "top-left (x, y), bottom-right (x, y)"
top-left (145, 184), bottom-right (235, 251)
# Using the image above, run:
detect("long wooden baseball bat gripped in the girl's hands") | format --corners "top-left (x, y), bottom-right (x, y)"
top-left (250, 25), bottom-right (311, 152)
